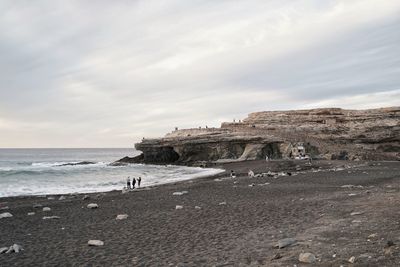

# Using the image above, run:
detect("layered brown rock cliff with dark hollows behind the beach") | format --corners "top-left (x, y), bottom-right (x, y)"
top-left (132, 107), bottom-right (400, 165)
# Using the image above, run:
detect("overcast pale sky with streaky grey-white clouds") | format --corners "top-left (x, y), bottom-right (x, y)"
top-left (0, 0), bottom-right (400, 147)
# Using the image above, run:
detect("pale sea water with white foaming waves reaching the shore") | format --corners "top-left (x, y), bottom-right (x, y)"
top-left (0, 148), bottom-right (225, 197)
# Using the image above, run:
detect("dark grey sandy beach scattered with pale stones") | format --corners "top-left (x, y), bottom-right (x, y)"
top-left (0, 161), bottom-right (400, 266)
